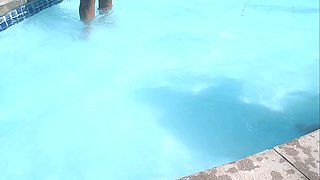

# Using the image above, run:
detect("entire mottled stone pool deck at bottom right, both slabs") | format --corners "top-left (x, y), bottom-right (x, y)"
top-left (179, 129), bottom-right (320, 180)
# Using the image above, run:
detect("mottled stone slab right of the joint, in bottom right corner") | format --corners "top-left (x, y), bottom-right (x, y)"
top-left (274, 130), bottom-right (320, 180)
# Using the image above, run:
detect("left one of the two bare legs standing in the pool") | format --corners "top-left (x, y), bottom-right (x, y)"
top-left (79, 0), bottom-right (95, 20)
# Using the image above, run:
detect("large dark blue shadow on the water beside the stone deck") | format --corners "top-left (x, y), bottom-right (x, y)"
top-left (134, 79), bottom-right (319, 158)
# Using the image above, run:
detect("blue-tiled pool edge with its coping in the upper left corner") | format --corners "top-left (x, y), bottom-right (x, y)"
top-left (0, 0), bottom-right (63, 32)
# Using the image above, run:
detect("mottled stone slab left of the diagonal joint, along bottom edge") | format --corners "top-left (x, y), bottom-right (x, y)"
top-left (180, 150), bottom-right (307, 180)
